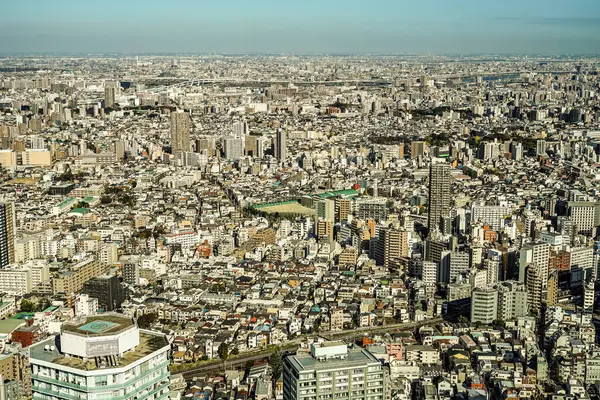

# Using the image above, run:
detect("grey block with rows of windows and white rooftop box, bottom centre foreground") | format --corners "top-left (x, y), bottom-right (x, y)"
top-left (283, 342), bottom-right (387, 400)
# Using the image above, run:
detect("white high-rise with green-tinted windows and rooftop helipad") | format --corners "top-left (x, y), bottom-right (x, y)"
top-left (29, 313), bottom-right (171, 400)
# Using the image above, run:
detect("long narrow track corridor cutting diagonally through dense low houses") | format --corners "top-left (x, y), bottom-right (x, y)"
top-left (182, 318), bottom-right (443, 381)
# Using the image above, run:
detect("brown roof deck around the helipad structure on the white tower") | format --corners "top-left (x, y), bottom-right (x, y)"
top-left (29, 332), bottom-right (169, 371)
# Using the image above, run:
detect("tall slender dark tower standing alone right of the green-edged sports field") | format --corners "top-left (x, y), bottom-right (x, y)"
top-left (427, 163), bottom-right (450, 232)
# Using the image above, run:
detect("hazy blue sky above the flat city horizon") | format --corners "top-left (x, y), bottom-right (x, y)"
top-left (0, 0), bottom-right (600, 54)
